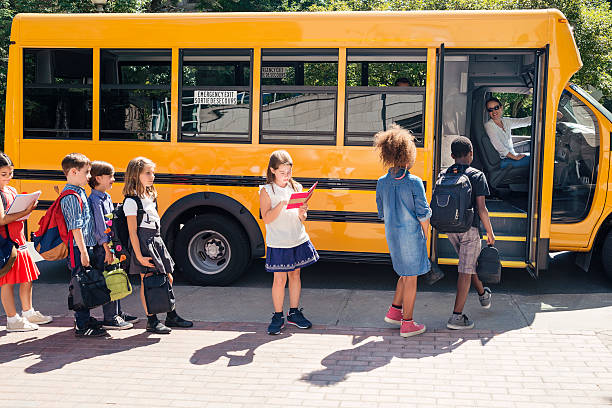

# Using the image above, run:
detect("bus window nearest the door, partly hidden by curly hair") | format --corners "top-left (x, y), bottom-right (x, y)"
top-left (345, 49), bottom-right (427, 147)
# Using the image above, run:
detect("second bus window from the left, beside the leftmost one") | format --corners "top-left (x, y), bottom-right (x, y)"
top-left (100, 50), bottom-right (172, 141)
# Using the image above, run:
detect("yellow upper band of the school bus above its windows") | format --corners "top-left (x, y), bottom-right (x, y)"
top-left (11, 9), bottom-right (581, 65)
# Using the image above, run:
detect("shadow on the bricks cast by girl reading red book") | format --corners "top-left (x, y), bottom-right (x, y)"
top-left (189, 333), bottom-right (291, 367)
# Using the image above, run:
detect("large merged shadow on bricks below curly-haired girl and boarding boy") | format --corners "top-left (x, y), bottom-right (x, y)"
top-left (301, 336), bottom-right (488, 386)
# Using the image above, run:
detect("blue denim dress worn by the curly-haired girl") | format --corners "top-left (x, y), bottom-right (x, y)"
top-left (376, 168), bottom-right (431, 276)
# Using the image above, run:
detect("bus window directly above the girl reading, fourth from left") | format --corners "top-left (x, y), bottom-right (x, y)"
top-left (260, 49), bottom-right (338, 144)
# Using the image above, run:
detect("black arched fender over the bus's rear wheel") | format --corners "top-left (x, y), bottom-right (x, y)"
top-left (161, 191), bottom-right (265, 258)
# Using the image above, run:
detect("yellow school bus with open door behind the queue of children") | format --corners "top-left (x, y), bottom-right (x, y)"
top-left (5, 10), bottom-right (612, 285)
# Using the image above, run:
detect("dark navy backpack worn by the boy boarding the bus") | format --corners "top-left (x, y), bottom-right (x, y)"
top-left (430, 166), bottom-right (474, 232)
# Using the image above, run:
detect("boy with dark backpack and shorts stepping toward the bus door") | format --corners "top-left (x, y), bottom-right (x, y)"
top-left (431, 136), bottom-right (495, 330)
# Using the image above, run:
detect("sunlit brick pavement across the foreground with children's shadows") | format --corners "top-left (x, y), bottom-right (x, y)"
top-left (0, 317), bottom-right (612, 408)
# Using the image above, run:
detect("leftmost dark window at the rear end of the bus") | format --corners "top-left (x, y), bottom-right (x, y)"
top-left (23, 49), bottom-right (93, 139)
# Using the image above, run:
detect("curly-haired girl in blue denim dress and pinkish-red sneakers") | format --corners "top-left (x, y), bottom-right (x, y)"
top-left (374, 125), bottom-right (431, 337)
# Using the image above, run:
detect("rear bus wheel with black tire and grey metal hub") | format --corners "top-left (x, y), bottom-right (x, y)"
top-left (174, 214), bottom-right (251, 286)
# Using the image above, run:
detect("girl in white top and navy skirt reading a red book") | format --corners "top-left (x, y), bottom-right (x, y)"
top-left (259, 150), bottom-right (319, 334)
